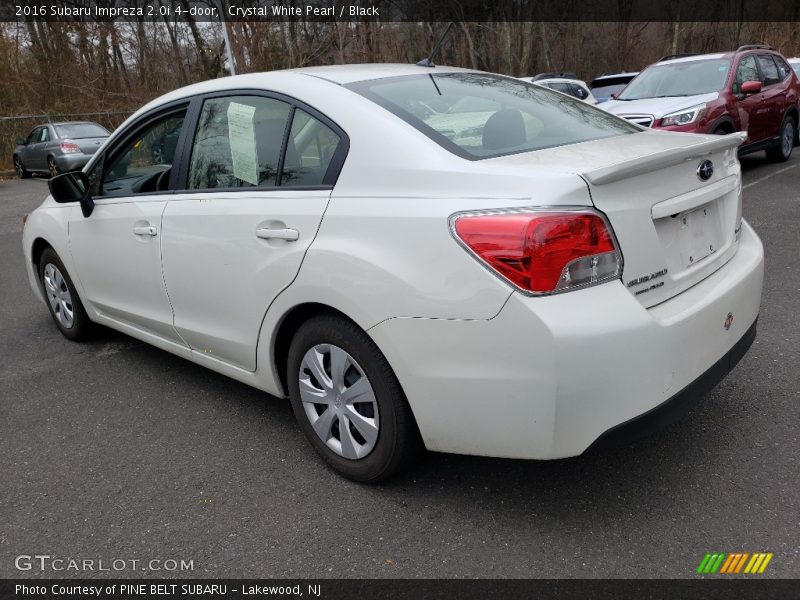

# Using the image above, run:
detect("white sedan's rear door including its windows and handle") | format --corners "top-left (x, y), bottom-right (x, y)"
top-left (162, 92), bottom-right (348, 371)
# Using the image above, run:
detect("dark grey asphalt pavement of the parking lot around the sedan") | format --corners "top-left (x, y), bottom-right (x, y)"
top-left (0, 153), bottom-right (800, 578)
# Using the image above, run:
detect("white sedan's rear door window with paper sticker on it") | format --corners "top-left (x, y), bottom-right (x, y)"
top-left (188, 96), bottom-right (291, 190)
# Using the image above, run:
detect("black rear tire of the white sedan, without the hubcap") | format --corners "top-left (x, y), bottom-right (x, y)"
top-left (286, 316), bottom-right (422, 483)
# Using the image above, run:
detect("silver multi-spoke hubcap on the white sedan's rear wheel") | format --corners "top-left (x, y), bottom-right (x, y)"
top-left (298, 344), bottom-right (380, 460)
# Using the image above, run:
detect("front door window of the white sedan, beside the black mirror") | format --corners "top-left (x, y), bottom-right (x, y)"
top-left (99, 109), bottom-right (186, 196)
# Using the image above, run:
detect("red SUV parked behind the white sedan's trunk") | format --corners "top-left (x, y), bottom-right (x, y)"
top-left (599, 45), bottom-right (800, 162)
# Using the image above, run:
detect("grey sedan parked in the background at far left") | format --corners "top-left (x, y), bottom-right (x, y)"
top-left (13, 121), bottom-right (110, 179)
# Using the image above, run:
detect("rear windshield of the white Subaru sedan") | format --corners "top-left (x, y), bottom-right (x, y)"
top-left (348, 73), bottom-right (640, 160)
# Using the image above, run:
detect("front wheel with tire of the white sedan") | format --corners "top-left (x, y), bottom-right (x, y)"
top-left (39, 248), bottom-right (91, 342)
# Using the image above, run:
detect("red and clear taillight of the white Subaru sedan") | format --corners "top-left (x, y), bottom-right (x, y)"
top-left (454, 210), bottom-right (622, 294)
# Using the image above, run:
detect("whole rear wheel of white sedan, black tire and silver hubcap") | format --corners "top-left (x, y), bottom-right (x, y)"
top-left (287, 316), bottom-right (421, 482)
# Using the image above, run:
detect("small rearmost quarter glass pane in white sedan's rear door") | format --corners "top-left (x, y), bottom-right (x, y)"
top-left (281, 108), bottom-right (340, 186)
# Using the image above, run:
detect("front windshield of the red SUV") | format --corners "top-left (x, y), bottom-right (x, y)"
top-left (617, 58), bottom-right (731, 100)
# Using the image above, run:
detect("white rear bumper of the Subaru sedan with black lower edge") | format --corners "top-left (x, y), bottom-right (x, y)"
top-left (369, 221), bottom-right (763, 459)
